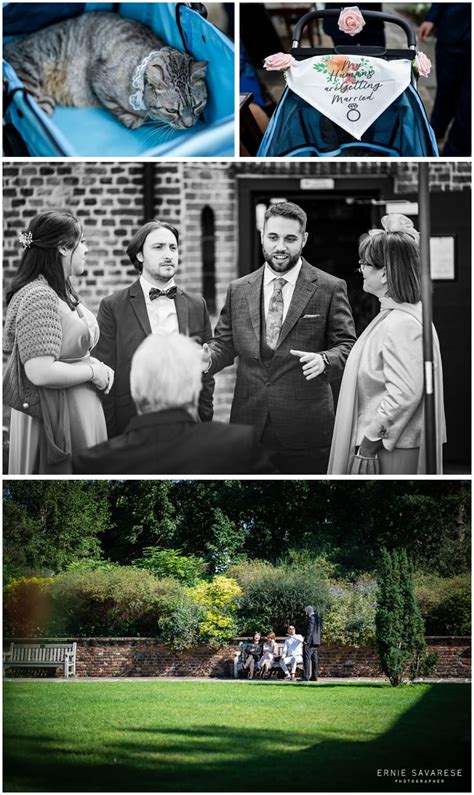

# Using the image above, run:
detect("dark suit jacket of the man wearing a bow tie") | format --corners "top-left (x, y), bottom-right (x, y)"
top-left (93, 280), bottom-right (214, 438)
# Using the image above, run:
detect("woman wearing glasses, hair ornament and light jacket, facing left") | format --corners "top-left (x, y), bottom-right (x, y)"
top-left (328, 213), bottom-right (446, 475)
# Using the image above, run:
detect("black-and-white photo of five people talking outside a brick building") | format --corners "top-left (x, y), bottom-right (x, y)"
top-left (4, 161), bottom-right (471, 475)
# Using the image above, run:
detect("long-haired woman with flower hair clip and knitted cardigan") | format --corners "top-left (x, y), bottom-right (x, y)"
top-left (3, 210), bottom-right (113, 474)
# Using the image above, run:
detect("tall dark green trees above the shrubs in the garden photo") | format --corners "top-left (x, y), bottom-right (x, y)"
top-left (4, 480), bottom-right (470, 577)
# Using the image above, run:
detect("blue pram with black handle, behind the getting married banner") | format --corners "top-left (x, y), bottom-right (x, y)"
top-left (257, 9), bottom-right (438, 157)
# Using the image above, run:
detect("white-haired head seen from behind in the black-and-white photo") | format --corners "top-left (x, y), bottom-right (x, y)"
top-left (130, 334), bottom-right (203, 414)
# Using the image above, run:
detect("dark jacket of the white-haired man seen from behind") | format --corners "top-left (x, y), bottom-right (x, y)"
top-left (73, 409), bottom-right (277, 475)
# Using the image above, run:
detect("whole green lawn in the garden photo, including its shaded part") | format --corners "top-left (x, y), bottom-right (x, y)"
top-left (4, 681), bottom-right (470, 792)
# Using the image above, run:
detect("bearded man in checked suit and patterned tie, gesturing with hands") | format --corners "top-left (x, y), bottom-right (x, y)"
top-left (204, 202), bottom-right (355, 474)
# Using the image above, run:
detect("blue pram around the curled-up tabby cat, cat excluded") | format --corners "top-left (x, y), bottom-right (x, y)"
top-left (3, 3), bottom-right (234, 157)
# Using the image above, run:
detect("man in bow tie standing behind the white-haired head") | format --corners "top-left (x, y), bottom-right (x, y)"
top-left (94, 221), bottom-right (214, 438)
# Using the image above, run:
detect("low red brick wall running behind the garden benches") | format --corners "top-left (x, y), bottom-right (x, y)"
top-left (4, 637), bottom-right (471, 679)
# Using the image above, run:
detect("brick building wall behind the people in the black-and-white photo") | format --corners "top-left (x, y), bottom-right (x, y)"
top-left (3, 161), bottom-right (471, 420)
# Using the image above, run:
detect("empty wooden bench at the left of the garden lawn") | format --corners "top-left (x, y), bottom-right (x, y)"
top-left (3, 643), bottom-right (77, 679)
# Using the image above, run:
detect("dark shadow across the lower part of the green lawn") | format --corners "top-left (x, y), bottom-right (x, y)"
top-left (4, 683), bottom-right (470, 792)
